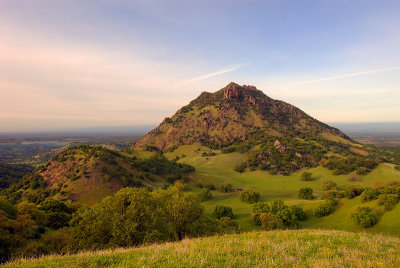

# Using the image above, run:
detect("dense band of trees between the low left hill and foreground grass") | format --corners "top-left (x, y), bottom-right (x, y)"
top-left (0, 182), bottom-right (239, 263)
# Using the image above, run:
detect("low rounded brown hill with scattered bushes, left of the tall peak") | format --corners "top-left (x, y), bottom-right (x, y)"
top-left (3, 145), bottom-right (194, 205)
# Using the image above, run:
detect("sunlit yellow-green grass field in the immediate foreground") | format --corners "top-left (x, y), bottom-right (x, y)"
top-left (5, 229), bottom-right (400, 267)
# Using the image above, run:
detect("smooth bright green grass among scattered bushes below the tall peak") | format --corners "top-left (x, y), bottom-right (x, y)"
top-left (161, 144), bottom-right (400, 235)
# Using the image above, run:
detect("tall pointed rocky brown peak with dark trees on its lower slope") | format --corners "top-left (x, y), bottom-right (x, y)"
top-left (132, 83), bottom-right (380, 175)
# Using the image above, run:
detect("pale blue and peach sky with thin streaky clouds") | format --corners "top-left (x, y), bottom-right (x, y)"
top-left (0, 0), bottom-right (400, 132)
